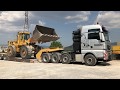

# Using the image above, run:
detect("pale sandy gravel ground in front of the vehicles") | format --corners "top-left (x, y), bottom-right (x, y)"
top-left (0, 60), bottom-right (120, 79)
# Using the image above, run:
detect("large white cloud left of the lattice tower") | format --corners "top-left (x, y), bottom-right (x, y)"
top-left (0, 11), bottom-right (25, 32)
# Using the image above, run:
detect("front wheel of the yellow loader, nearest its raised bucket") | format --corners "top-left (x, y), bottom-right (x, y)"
top-left (20, 46), bottom-right (32, 59)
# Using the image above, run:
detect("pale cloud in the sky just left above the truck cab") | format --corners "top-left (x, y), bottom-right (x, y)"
top-left (65, 11), bottom-right (90, 23)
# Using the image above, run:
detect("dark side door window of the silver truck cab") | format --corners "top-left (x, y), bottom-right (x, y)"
top-left (88, 29), bottom-right (100, 40)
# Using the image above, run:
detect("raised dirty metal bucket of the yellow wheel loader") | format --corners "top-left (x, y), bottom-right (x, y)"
top-left (31, 25), bottom-right (59, 43)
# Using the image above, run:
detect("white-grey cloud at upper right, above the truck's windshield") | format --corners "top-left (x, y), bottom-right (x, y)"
top-left (95, 11), bottom-right (120, 29)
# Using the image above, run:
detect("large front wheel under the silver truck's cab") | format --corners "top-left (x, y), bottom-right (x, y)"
top-left (84, 54), bottom-right (97, 66)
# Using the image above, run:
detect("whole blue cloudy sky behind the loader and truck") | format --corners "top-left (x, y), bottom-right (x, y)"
top-left (0, 11), bottom-right (120, 46)
